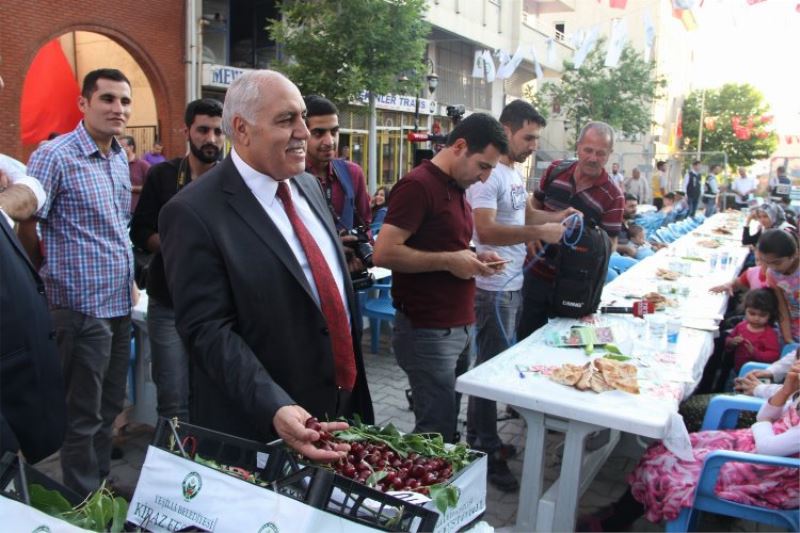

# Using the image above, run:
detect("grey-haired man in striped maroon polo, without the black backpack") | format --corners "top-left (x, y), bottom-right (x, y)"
top-left (517, 122), bottom-right (625, 339)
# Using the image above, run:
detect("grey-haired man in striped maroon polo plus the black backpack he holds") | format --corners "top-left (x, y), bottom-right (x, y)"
top-left (517, 122), bottom-right (625, 339)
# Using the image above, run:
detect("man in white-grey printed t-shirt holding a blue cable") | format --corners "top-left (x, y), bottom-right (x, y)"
top-left (467, 100), bottom-right (572, 492)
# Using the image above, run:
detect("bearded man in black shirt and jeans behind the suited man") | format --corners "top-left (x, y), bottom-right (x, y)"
top-left (131, 98), bottom-right (225, 420)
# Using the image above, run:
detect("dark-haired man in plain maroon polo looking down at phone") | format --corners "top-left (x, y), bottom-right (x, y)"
top-left (373, 113), bottom-right (508, 441)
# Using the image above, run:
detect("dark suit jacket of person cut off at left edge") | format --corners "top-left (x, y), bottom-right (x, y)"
top-left (0, 170), bottom-right (66, 463)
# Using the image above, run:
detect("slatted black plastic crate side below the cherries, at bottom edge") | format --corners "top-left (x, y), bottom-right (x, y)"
top-left (276, 466), bottom-right (439, 531)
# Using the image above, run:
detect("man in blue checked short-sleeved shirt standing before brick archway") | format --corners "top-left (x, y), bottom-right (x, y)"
top-left (28, 69), bottom-right (133, 494)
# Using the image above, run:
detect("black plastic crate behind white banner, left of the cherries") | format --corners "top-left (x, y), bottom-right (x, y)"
top-left (151, 417), bottom-right (300, 482)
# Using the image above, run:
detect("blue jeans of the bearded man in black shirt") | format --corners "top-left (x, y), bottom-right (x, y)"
top-left (147, 298), bottom-right (189, 420)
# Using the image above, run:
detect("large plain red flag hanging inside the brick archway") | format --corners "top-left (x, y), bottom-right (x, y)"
top-left (20, 39), bottom-right (83, 144)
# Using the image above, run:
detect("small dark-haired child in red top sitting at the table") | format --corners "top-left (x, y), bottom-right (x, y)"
top-left (725, 289), bottom-right (781, 379)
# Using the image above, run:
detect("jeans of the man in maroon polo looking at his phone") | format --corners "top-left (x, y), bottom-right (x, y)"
top-left (392, 311), bottom-right (472, 442)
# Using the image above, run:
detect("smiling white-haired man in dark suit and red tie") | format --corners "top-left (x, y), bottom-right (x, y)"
top-left (159, 71), bottom-right (373, 460)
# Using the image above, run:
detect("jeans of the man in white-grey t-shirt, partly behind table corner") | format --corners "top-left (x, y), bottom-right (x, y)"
top-left (467, 289), bottom-right (522, 453)
